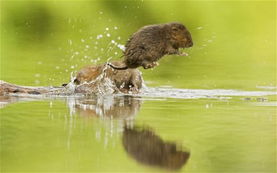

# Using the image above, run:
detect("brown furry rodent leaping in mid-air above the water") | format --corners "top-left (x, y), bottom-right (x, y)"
top-left (108, 22), bottom-right (193, 70)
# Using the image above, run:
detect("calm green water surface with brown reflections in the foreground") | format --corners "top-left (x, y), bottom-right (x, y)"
top-left (0, 87), bottom-right (277, 172)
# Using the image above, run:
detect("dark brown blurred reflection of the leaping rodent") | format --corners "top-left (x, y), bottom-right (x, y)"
top-left (122, 128), bottom-right (190, 170)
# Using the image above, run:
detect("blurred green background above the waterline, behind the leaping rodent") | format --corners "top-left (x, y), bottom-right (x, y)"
top-left (0, 0), bottom-right (276, 89)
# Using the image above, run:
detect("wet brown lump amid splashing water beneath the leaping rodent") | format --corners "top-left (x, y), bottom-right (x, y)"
top-left (74, 61), bottom-right (142, 93)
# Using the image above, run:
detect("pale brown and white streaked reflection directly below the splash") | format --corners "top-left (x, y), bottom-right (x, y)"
top-left (65, 95), bottom-right (141, 150)
